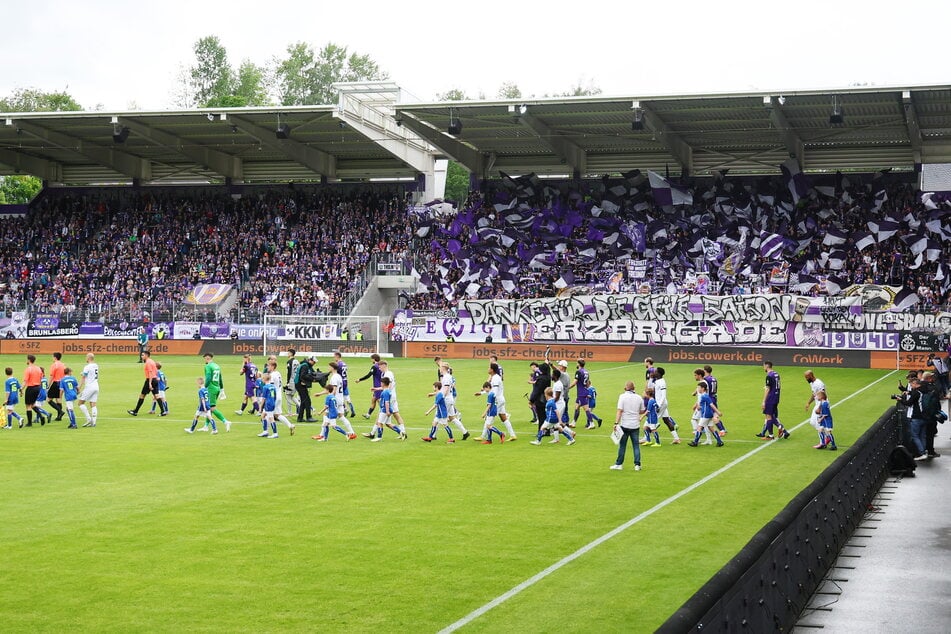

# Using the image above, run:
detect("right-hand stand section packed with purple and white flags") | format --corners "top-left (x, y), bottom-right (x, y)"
top-left (408, 172), bottom-right (951, 311)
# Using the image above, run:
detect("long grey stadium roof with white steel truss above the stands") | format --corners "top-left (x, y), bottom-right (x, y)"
top-left (0, 82), bottom-right (951, 184)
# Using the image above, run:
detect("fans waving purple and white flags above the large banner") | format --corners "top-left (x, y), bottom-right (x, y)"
top-left (407, 173), bottom-right (951, 311)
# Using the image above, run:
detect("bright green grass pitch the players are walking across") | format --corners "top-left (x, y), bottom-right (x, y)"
top-left (0, 356), bottom-right (897, 632)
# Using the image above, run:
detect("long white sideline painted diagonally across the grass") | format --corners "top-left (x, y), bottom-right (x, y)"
top-left (439, 370), bottom-right (898, 634)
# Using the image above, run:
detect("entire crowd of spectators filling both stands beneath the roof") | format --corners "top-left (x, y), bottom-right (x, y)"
top-left (0, 173), bottom-right (951, 319)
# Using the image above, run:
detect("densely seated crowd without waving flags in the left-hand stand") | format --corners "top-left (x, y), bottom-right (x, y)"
top-left (0, 183), bottom-right (407, 320)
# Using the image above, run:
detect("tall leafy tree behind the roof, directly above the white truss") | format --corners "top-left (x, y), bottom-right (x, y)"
top-left (275, 42), bottom-right (388, 106)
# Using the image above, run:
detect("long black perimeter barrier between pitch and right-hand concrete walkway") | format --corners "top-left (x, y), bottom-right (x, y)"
top-left (657, 407), bottom-right (900, 634)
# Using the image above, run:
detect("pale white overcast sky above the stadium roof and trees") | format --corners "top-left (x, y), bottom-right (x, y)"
top-left (7, 0), bottom-right (951, 111)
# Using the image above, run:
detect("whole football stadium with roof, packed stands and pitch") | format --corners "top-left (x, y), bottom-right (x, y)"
top-left (0, 21), bottom-right (951, 632)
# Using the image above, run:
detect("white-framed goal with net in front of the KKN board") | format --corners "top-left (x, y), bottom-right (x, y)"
top-left (262, 314), bottom-right (386, 358)
